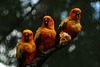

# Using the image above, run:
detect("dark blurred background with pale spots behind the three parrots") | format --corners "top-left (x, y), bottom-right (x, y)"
top-left (0, 0), bottom-right (100, 67)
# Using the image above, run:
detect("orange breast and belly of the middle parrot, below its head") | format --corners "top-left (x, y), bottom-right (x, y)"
top-left (39, 28), bottom-right (56, 51)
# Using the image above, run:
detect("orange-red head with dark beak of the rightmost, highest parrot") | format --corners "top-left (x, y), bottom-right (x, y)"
top-left (69, 8), bottom-right (81, 22)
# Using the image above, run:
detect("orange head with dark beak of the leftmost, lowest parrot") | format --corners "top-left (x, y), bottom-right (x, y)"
top-left (21, 29), bottom-right (33, 42)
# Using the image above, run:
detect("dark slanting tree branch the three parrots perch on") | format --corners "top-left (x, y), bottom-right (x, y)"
top-left (26, 42), bottom-right (71, 67)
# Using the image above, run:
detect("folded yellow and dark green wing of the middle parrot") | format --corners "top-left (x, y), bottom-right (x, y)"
top-left (34, 27), bottom-right (42, 52)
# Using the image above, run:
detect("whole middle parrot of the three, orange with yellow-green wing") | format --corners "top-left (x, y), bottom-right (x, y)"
top-left (34, 16), bottom-right (56, 53)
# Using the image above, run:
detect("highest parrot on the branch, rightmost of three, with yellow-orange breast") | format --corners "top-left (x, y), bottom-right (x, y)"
top-left (56, 8), bottom-right (82, 44)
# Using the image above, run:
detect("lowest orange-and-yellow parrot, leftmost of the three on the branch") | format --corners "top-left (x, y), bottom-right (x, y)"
top-left (16, 29), bottom-right (36, 67)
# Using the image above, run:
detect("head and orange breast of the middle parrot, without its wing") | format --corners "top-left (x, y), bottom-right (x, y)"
top-left (39, 16), bottom-right (56, 52)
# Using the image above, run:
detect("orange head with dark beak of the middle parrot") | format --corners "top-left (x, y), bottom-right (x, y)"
top-left (42, 16), bottom-right (54, 29)
